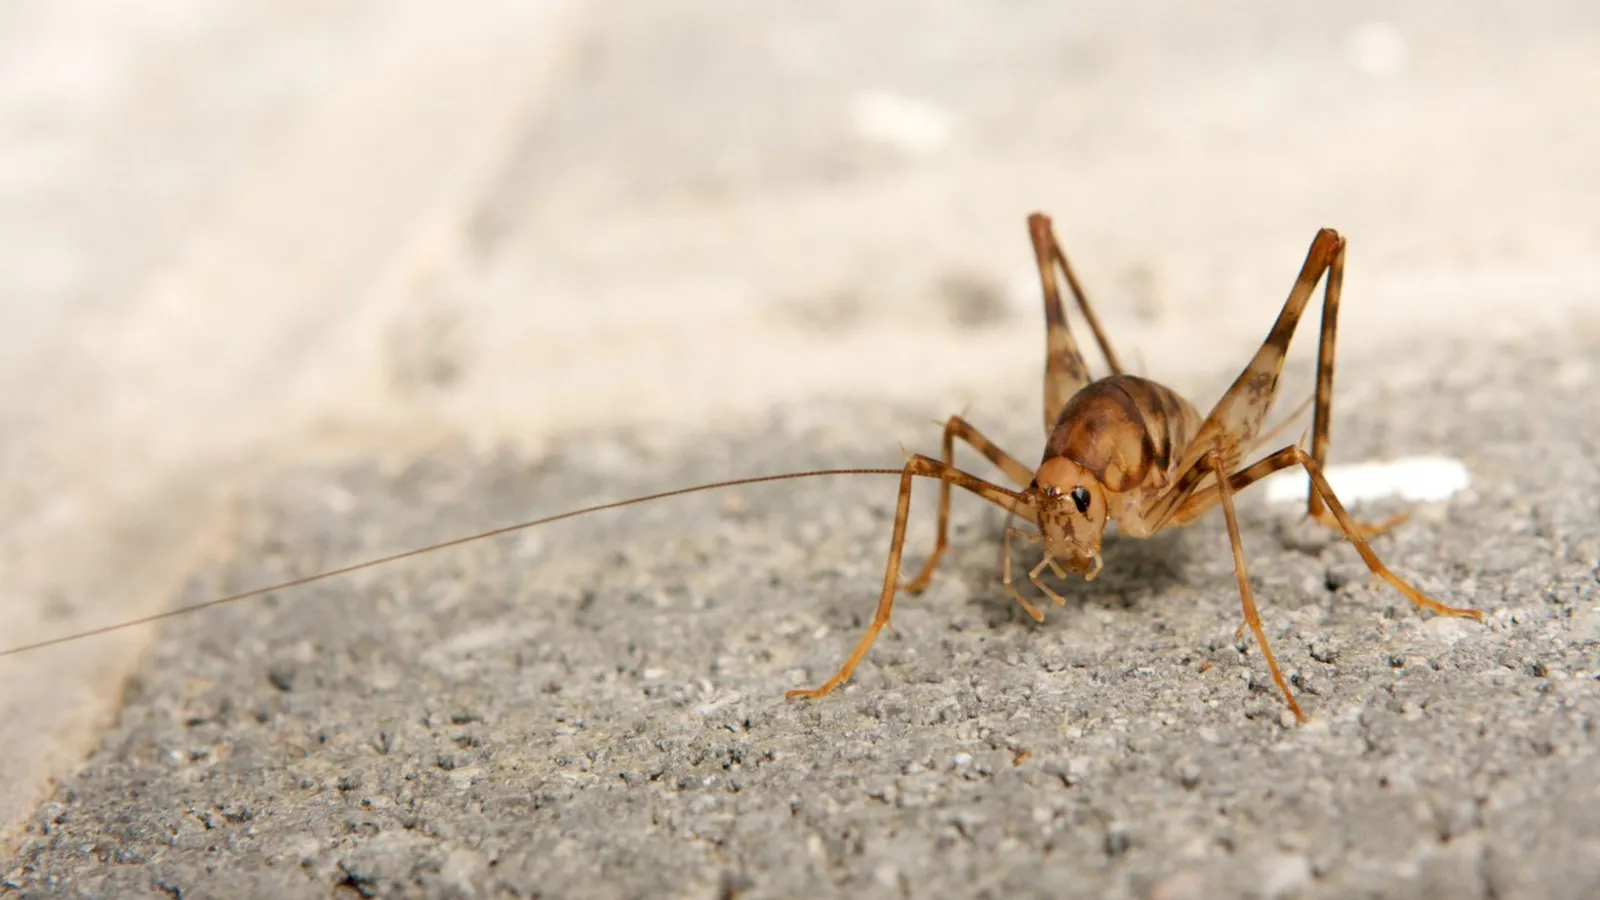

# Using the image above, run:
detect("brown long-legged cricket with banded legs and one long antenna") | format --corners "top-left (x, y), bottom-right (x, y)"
top-left (0, 213), bottom-right (1483, 722)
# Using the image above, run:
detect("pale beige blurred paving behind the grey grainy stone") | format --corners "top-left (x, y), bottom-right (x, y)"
top-left (0, 0), bottom-right (1600, 839)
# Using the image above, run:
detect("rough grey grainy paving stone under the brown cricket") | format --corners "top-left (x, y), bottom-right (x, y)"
top-left (0, 335), bottom-right (1600, 900)
